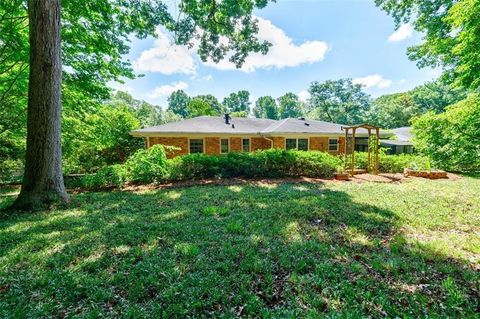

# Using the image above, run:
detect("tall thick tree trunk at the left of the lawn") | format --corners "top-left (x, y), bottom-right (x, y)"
top-left (13, 0), bottom-right (68, 210)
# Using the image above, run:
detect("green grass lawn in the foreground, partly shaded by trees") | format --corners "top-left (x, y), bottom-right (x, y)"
top-left (0, 177), bottom-right (480, 318)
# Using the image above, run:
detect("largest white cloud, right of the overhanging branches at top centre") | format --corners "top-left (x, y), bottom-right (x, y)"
top-left (205, 17), bottom-right (329, 72)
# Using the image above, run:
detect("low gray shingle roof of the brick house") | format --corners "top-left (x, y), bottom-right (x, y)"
top-left (131, 116), bottom-right (391, 136)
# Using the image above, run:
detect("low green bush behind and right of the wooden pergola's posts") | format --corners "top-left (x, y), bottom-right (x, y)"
top-left (352, 151), bottom-right (430, 173)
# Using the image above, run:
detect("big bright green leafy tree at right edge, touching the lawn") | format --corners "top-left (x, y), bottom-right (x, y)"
top-left (413, 94), bottom-right (480, 171)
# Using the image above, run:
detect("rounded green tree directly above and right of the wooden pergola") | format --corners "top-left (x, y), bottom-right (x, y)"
top-left (366, 92), bottom-right (419, 128)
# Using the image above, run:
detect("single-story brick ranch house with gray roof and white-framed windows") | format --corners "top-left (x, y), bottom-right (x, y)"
top-left (130, 115), bottom-right (392, 158)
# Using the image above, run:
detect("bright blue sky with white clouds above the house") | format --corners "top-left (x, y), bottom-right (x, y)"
top-left (114, 0), bottom-right (439, 107)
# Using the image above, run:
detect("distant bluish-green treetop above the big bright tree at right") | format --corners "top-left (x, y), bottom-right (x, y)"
top-left (409, 81), bottom-right (467, 113)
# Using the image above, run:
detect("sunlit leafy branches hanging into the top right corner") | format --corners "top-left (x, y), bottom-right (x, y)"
top-left (375, 0), bottom-right (480, 89)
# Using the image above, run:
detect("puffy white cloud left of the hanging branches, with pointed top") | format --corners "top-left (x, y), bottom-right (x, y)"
top-left (134, 29), bottom-right (196, 74)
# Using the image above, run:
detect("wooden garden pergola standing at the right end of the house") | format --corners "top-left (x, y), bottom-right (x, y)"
top-left (342, 124), bottom-right (380, 176)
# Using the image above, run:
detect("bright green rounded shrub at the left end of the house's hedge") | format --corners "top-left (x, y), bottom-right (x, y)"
top-left (124, 145), bottom-right (169, 183)
